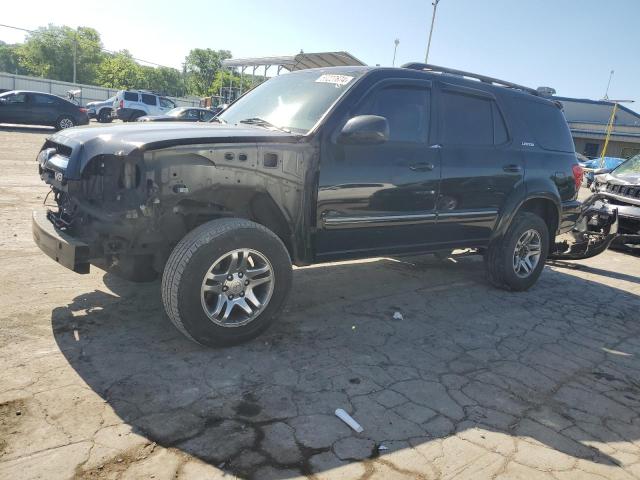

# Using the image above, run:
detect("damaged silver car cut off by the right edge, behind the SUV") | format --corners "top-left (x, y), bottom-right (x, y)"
top-left (594, 155), bottom-right (640, 247)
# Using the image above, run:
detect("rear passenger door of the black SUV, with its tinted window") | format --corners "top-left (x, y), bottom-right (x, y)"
top-left (437, 83), bottom-right (523, 246)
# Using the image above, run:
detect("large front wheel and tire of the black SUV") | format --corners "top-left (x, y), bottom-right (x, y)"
top-left (162, 218), bottom-right (292, 346)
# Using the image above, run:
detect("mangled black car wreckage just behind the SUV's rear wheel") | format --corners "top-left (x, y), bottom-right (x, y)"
top-left (549, 193), bottom-right (619, 260)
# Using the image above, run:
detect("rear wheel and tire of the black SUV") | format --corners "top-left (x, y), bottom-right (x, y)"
top-left (484, 212), bottom-right (549, 291)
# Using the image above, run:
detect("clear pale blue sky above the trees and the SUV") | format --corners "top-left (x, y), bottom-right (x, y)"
top-left (0, 0), bottom-right (640, 111)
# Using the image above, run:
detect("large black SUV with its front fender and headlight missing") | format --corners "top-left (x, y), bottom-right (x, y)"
top-left (33, 64), bottom-right (617, 345)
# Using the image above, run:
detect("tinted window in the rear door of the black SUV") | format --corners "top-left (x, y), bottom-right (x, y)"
top-left (441, 91), bottom-right (496, 145)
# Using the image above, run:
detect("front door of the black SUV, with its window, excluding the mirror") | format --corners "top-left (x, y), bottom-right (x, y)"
top-left (316, 80), bottom-right (440, 260)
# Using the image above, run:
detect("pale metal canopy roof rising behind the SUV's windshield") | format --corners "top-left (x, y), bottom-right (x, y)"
top-left (222, 52), bottom-right (365, 72)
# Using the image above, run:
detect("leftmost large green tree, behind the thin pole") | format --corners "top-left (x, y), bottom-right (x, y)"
top-left (18, 25), bottom-right (104, 84)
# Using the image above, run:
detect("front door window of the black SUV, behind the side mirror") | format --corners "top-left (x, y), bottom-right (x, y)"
top-left (356, 86), bottom-right (431, 143)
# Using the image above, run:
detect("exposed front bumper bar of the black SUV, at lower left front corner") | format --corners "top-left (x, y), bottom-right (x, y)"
top-left (31, 211), bottom-right (90, 273)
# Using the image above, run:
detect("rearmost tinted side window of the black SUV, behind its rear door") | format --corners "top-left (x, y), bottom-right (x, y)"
top-left (514, 98), bottom-right (575, 153)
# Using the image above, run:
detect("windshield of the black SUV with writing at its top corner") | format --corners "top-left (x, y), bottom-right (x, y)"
top-left (217, 70), bottom-right (363, 134)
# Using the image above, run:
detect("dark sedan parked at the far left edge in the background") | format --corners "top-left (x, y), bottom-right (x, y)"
top-left (0, 90), bottom-right (89, 130)
